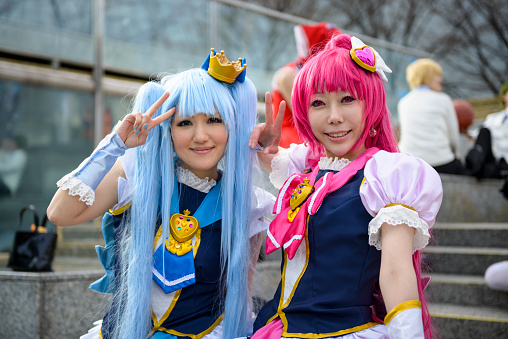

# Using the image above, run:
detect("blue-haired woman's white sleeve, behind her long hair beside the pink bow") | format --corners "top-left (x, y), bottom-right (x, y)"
top-left (248, 187), bottom-right (275, 238)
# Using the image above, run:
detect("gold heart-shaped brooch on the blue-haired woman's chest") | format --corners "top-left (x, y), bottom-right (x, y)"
top-left (166, 210), bottom-right (199, 256)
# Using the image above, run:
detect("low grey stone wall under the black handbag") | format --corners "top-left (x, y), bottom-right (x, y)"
top-left (0, 271), bottom-right (110, 339)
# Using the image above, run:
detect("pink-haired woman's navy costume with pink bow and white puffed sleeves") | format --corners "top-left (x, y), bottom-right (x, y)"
top-left (254, 148), bottom-right (442, 338)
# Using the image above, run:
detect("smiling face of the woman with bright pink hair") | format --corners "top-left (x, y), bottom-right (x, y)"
top-left (308, 92), bottom-right (366, 160)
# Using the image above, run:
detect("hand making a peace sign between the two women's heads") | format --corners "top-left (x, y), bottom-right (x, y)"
top-left (249, 92), bottom-right (286, 154)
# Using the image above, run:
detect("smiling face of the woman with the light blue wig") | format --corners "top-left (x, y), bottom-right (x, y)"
top-left (171, 112), bottom-right (228, 180)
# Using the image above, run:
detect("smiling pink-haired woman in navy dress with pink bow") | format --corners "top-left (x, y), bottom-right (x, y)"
top-left (253, 35), bottom-right (442, 339)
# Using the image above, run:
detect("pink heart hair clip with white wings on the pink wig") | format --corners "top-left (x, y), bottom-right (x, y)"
top-left (349, 36), bottom-right (392, 81)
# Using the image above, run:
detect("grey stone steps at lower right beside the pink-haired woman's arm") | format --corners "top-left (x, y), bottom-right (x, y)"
top-left (424, 222), bottom-right (508, 339)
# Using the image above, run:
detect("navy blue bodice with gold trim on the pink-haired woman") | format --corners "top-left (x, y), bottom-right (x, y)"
top-left (254, 170), bottom-right (381, 338)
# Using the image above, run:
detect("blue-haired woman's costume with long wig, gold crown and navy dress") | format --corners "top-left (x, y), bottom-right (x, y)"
top-left (57, 49), bottom-right (274, 339)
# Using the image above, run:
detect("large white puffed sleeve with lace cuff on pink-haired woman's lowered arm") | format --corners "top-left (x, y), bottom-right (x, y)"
top-left (360, 151), bottom-right (443, 252)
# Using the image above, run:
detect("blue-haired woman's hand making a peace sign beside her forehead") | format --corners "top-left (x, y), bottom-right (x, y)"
top-left (116, 92), bottom-right (176, 148)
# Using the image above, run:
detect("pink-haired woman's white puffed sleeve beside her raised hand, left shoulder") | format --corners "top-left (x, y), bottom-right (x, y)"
top-left (269, 144), bottom-right (311, 189)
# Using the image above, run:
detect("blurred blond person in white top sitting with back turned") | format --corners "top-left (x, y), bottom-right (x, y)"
top-left (398, 58), bottom-right (465, 174)
